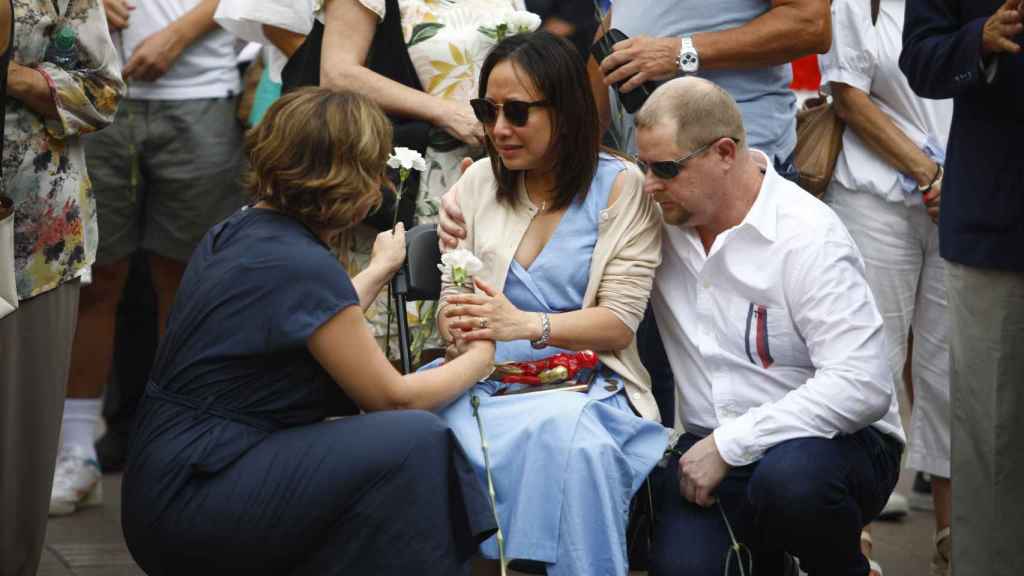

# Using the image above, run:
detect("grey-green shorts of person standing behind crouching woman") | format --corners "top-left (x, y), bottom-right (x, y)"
top-left (82, 98), bottom-right (244, 264)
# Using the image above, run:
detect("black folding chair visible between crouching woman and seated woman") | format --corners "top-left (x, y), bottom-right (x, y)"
top-left (391, 224), bottom-right (441, 374)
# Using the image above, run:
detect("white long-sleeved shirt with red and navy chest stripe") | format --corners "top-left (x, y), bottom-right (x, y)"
top-left (652, 151), bottom-right (905, 466)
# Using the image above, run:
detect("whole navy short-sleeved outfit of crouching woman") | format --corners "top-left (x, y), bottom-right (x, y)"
top-left (122, 208), bottom-right (495, 576)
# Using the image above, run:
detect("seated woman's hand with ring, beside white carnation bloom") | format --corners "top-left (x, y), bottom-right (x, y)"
top-left (444, 278), bottom-right (530, 341)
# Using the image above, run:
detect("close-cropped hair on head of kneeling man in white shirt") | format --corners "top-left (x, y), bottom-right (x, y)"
top-left (635, 76), bottom-right (746, 152)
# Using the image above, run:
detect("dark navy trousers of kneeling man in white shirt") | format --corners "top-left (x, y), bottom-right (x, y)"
top-left (650, 427), bottom-right (902, 576)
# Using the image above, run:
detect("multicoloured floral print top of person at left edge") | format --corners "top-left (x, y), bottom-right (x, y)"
top-left (0, 0), bottom-right (124, 300)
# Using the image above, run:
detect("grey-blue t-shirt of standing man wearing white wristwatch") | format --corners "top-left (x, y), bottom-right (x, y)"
top-left (611, 0), bottom-right (797, 160)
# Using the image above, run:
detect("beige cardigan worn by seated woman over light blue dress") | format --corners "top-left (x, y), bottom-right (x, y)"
top-left (444, 158), bottom-right (662, 420)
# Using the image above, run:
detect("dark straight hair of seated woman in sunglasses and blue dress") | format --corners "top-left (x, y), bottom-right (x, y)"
top-left (479, 32), bottom-right (601, 209)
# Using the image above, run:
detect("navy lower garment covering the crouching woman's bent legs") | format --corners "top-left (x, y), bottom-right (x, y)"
top-left (125, 411), bottom-right (494, 576)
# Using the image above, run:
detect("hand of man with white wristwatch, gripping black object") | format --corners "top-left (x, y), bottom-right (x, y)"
top-left (601, 36), bottom-right (682, 92)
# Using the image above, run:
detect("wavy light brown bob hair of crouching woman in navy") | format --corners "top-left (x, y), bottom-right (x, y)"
top-left (246, 87), bottom-right (391, 233)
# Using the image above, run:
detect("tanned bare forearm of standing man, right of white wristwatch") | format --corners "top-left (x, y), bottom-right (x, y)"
top-left (693, 0), bottom-right (831, 70)
